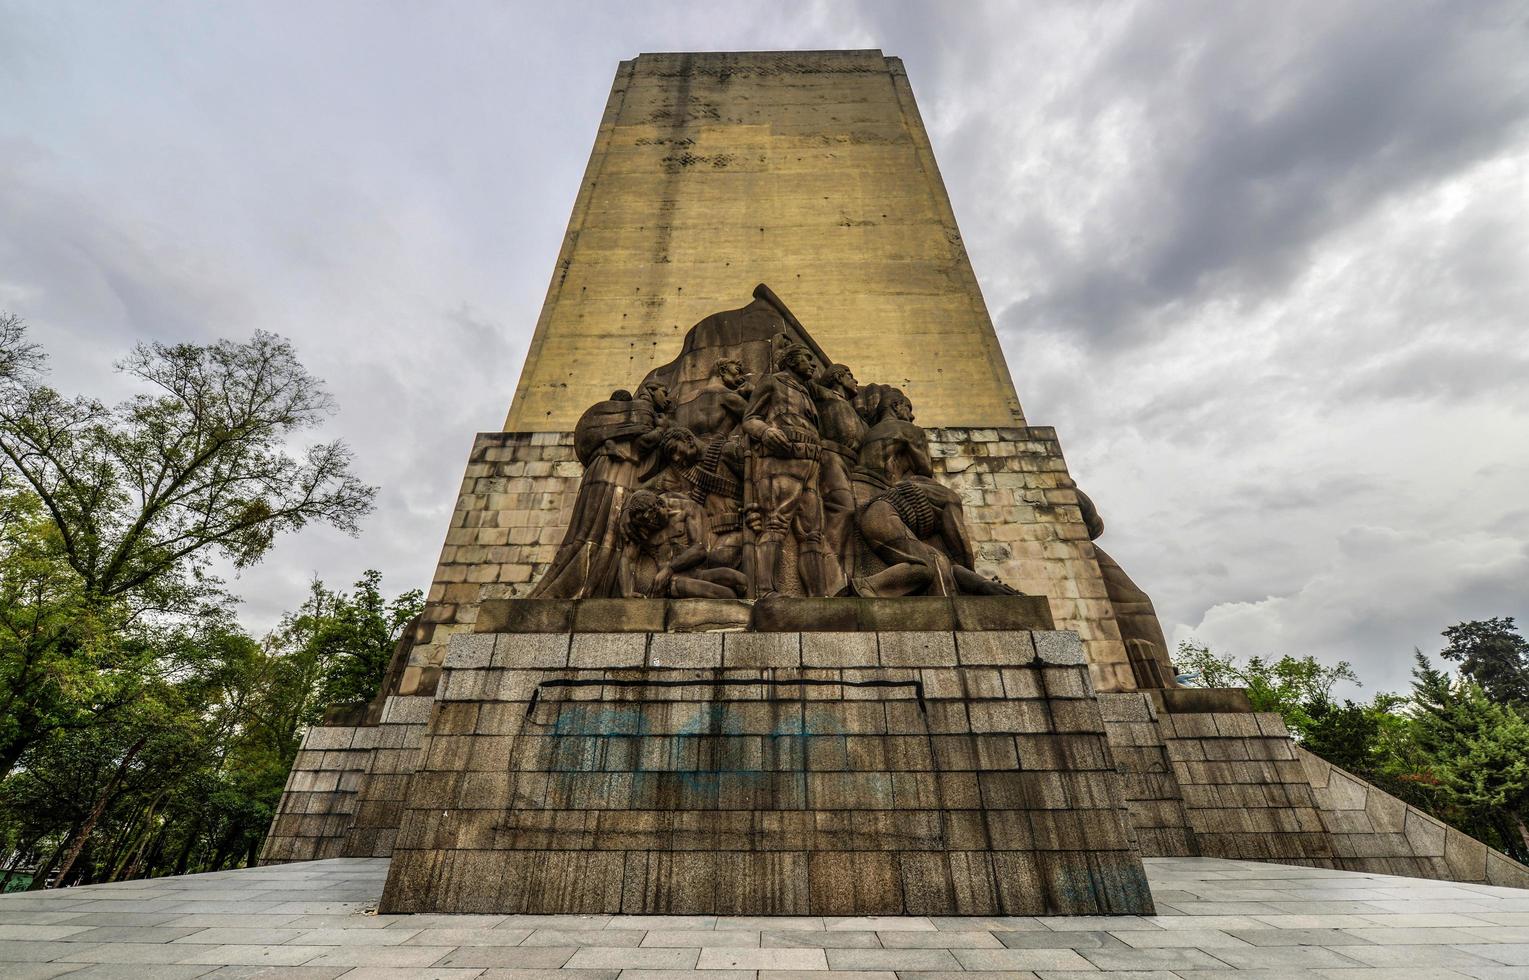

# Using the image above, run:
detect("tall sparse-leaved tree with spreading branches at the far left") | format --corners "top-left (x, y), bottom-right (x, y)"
top-left (0, 315), bottom-right (375, 777)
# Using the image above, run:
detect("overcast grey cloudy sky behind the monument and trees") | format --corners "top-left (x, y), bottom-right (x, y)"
top-left (0, 0), bottom-right (1529, 691)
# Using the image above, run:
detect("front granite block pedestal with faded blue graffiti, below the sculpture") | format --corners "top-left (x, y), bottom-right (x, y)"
top-left (382, 631), bottom-right (1151, 914)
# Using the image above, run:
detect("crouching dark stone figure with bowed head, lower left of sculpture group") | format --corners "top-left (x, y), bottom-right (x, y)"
top-left (619, 489), bottom-right (748, 599)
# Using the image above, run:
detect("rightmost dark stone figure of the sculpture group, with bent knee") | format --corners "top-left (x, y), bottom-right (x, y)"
top-left (850, 385), bottom-right (1018, 596)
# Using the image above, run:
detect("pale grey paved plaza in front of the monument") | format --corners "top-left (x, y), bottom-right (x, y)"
top-left (0, 858), bottom-right (1529, 980)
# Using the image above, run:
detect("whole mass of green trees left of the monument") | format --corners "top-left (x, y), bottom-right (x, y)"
top-left (0, 315), bottom-right (420, 891)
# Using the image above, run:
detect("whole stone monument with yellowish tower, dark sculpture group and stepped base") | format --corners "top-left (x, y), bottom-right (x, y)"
top-left (263, 52), bottom-right (1529, 914)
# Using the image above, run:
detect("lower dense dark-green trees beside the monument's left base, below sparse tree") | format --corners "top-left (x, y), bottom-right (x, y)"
top-left (0, 572), bottom-right (422, 887)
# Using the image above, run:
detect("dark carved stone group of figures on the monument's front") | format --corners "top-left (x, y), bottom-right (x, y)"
top-left (532, 304), bottom-right (1017, 599)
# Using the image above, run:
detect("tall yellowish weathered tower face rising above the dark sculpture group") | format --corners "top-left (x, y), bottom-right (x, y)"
top-left (505, 50), bottom-right (1024, 431)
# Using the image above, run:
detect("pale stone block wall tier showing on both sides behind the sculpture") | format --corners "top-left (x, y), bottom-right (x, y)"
top-left (396, 427), bottom-right (1136, 694)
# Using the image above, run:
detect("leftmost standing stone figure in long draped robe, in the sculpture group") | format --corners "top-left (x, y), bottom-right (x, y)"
top-left (531, 384), bottom-right (670, 599)
